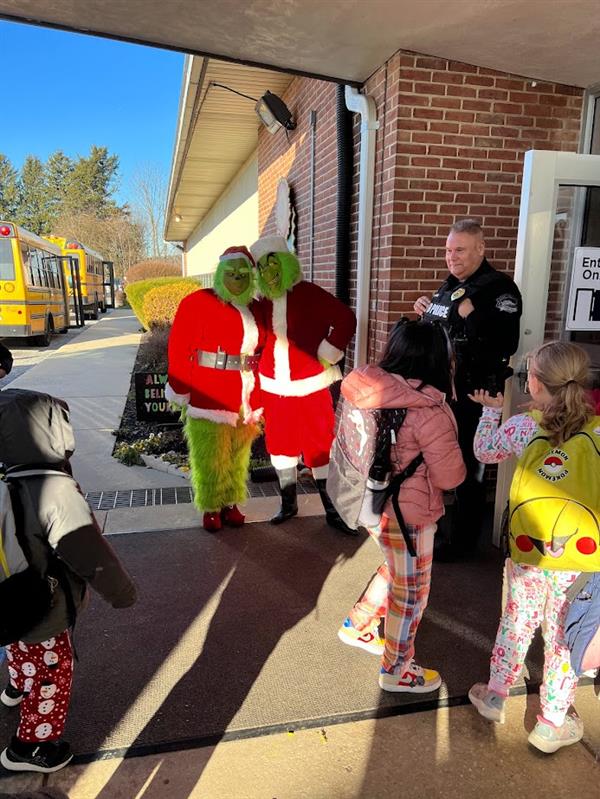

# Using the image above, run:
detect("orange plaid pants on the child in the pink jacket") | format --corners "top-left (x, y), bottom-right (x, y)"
top-left (349, 515), bottom-right (436, 669)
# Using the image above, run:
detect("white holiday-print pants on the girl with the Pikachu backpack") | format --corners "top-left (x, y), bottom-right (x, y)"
top-left (488, 559), bottom-right (579, 726)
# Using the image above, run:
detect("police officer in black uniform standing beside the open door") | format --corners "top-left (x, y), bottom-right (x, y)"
top-left (414, 219), bottom-right (522, 560)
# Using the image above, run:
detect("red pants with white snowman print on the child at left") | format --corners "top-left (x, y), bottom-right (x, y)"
top-left (6, 630), bottom-right (73, 742)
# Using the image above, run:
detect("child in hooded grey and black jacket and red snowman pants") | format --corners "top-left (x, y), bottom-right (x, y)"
top-left (0, 389), bottom-right (136, 774)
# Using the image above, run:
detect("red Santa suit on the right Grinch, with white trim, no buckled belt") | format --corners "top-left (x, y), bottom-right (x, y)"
top-left (259, 281), bottom-right (356, 478)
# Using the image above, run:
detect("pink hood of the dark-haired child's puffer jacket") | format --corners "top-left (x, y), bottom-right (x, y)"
top-left (342, 366), bottom-right (446, 409)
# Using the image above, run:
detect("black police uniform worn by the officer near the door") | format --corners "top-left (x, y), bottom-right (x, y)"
top-left (423, 258), bottom-right (522, 552)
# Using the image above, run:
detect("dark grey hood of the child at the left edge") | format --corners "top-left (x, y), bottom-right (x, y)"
top-left (0, 388), bottom-right (75, 466)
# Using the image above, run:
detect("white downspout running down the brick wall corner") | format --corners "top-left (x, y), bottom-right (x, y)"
top-left (346, 86), bottom-right (379, 367)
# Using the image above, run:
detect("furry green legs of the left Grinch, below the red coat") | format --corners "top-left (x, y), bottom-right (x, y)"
top-left (184, 416), bottom-right (255, 513)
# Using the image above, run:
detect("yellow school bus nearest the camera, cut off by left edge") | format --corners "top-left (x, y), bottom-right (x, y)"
top-left (0, 221), bottom-right (69, 347)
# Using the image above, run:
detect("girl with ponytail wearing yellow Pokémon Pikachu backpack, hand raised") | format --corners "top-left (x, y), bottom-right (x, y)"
top-left (469, 342), bottom-right (600, 753)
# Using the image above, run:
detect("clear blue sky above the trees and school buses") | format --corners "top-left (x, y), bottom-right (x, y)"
top-left (0, 20), bottom-right (184, 202)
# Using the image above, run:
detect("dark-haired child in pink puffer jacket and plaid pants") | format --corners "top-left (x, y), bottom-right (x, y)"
top-left (338, 320), bottom-right (465, 693)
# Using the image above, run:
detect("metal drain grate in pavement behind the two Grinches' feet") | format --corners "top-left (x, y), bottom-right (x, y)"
top-left (85, 478), bottom-right (317, 510)
